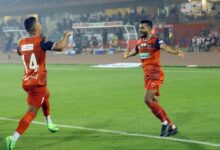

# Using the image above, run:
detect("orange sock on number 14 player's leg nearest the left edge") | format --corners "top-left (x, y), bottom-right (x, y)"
top-left (16, 112), bottom-right (36, 135)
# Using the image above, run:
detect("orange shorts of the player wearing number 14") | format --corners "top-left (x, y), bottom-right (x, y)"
top-left (23, 85), bottom-right (49, 108)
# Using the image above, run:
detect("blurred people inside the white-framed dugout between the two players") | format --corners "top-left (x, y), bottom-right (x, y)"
top-left (68, 29), bottom-right (127, 54)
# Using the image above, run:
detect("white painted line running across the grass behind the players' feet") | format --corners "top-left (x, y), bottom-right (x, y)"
top-left (0, 117), bottom-right (220, 147)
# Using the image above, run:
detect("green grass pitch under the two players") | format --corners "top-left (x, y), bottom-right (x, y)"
top-left (0, 64), bottom-right (220, 150)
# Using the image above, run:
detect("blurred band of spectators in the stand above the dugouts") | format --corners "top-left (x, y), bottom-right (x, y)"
top-left (1, 6), bottom-right (220, 32)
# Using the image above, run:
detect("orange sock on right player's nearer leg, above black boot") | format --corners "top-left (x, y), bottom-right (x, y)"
top-left (147, 101), bottom-right (166, 122)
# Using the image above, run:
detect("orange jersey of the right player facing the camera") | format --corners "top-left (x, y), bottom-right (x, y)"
top-left (136, 36), bottom-right (164, 81)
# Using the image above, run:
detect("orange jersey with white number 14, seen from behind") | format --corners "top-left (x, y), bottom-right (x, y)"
top-left (18, 36), bottom-right (52, 85)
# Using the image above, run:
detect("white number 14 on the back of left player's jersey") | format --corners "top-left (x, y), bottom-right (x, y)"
top-left (22, 53), bottom-right (39, 73)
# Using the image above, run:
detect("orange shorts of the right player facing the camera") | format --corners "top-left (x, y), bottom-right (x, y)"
top-left (144, 79), bottom-right (163, 96)
